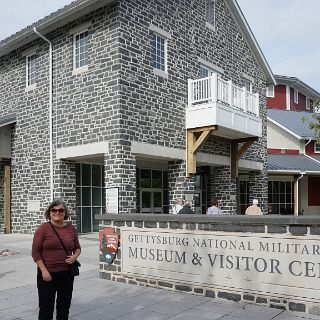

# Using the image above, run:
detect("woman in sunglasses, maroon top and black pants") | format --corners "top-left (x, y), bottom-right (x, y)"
top-left (32, 199), bottom-right (81, 320)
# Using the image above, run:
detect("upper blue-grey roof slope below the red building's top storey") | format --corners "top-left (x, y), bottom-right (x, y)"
top-left (267, 109), bottom-right (315, 139)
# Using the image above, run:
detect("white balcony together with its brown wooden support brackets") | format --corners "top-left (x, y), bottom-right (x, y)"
top-left (186, 75), bottom-right (262, 180)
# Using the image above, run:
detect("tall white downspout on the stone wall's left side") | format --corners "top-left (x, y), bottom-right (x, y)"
top-left (33, 27), bottom-right (53, 202)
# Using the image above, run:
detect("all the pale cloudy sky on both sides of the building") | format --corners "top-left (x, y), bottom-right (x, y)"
top-left (0, 0), bottom-right (320, 92)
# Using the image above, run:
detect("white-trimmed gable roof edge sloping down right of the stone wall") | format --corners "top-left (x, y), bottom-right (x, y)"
top-left (225, 0), bottom-right (277, 84)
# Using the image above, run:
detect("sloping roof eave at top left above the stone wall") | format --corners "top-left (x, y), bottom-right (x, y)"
top-left (0, 0), bottom-right (115, 57)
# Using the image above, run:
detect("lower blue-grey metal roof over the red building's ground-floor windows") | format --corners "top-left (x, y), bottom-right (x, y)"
top-left (267, 154), bottom-right (320, 174)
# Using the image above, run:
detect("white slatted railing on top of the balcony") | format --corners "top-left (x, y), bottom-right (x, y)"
top-left (188, 75), bottom-right (259, 117)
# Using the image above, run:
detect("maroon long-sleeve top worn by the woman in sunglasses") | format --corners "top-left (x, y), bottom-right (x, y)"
top-left (32, 222), bottom-right (80, 272)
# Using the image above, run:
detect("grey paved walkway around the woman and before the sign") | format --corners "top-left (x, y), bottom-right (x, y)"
top-left (0, 234), bottom-right (320, 320)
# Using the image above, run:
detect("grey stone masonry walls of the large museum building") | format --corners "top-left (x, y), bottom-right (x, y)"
top-left (0, 0), bottom-right (266, 232)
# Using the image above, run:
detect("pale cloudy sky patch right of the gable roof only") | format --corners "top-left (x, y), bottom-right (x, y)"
top-left (238, 0), bottom-right (320, 91)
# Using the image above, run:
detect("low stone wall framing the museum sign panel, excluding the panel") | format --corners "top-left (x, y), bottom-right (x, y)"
top-left (100, 215), bottom-right (320, 315)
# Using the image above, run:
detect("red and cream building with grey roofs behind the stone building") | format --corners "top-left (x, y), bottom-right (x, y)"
top-left (267, 75), bottom-right (320, 215)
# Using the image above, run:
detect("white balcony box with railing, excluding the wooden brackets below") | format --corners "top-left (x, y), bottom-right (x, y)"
top-left (186, 75), bottom-right (262, 139)
